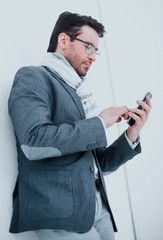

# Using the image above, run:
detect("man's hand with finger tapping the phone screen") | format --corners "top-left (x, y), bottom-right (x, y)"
top-left (98, 106), bottom-right (128, 128)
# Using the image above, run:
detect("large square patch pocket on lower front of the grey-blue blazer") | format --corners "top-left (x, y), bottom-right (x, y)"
top-left (23, 171), bottom-right (73, 219)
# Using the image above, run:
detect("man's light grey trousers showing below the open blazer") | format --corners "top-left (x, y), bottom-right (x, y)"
top-left (35, 183), bottom-right (115, 240)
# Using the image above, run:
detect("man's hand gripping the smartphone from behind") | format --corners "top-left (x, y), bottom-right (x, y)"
top-left (127, 96), bottom-right (152, 143)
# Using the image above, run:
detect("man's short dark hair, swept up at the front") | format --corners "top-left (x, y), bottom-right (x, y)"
top-left (47, 11), bottom-right (105, 52)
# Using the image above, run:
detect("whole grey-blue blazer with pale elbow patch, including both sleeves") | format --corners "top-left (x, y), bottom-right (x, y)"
top-left (8, 66), bottom-right (141, 233)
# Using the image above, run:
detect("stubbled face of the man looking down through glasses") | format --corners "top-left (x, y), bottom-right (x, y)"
top-left (64, 26), bottom-right (99, 76)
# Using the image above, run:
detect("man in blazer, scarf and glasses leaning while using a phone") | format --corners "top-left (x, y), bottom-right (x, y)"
top-left (9, 12), bottom-right (151, 240)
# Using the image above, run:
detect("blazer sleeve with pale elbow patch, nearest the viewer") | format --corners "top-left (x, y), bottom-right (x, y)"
top-left (8, 67), bottom-right (107, 160)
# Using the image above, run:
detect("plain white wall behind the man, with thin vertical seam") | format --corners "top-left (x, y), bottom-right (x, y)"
top-left (0, 0), bottom-right (163, 240)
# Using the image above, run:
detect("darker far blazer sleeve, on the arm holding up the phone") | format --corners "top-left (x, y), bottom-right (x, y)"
top-left (96, 133), bottom-right (141, 174)
